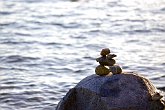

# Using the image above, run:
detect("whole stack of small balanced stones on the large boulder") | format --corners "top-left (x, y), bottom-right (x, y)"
top-left (95, 48), bottom-right (122, 76)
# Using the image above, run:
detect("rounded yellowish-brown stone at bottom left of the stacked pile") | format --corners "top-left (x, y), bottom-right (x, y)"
top-left (95, 65), bottom-right (110, 76)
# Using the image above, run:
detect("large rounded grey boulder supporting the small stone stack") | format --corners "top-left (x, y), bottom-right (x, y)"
top-left (56, 73), bottom-right (165, 110)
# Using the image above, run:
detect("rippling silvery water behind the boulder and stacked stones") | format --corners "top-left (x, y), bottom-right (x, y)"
top-left (0, 0), bottom-right (165, 110)
